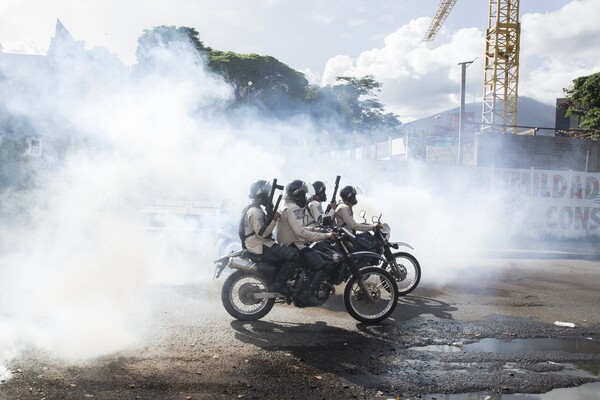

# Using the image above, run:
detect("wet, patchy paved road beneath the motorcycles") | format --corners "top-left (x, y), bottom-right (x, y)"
top-left (0, 252), bottom-right (600, 400)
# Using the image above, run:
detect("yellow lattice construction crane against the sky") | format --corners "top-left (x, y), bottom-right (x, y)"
top-left (423, 0), bottom-right (521, 133)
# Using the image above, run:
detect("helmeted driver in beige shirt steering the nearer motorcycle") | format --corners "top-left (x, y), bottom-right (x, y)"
top-left (277, 180), bottom-right (336, 302)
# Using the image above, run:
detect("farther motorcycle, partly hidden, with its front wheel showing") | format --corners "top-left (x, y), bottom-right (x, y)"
top-left (346, 210), bottom-right (421, 296)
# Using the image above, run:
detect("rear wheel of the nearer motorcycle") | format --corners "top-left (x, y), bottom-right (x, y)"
top-left (221, 271), bottom-right (275, 321)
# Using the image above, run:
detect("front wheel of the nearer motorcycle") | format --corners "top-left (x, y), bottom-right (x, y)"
top-left (344, 267), bottom-right (398, 324)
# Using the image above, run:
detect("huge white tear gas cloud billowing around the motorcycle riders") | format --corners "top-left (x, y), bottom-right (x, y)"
top-left (0, 32), bottom-right (540, 379)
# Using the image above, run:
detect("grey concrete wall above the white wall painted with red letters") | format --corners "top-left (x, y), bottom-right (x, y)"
top-left (474, 133), bottom-right (600, 172)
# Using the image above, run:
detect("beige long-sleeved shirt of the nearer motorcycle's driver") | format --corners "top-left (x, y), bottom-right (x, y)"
top-left (277, 200), bottom-right (329, 249)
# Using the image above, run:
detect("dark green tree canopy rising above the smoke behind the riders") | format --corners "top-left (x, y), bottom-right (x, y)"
top-left (136, 26), bottom-right (401, 136)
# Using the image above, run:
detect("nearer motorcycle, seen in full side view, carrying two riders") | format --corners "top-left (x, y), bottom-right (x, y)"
top-left (213, 230), bottom-right (398, 324)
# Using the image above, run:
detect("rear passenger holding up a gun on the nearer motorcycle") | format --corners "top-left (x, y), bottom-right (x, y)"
top-left (240, 180), bottom-right (298, 294)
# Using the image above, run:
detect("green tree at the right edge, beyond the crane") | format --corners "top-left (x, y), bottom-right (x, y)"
top-left (564, 72), bottom-right (600, 139)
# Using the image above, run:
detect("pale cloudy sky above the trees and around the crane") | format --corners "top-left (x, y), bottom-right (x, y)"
top-left (0, 0), bottom-right (600, 122)
